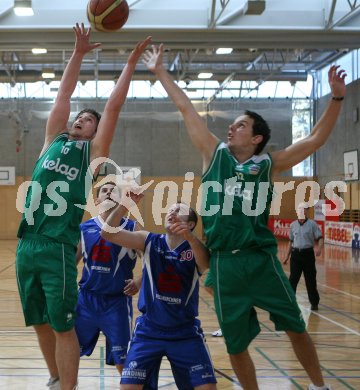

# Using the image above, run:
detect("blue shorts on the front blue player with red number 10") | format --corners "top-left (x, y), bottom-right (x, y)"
top-left (121, 316), bottom-right (216, 390)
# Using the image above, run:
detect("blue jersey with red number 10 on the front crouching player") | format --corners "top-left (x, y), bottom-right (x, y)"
top-left (138, 233), bottom-right (200, 328)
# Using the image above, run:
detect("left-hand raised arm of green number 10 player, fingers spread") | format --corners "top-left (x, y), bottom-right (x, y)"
top-left (45, 23), bottom-right (101, 146)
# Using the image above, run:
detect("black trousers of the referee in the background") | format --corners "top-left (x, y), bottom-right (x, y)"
top-left (289, 248), bottom-right (320, 306)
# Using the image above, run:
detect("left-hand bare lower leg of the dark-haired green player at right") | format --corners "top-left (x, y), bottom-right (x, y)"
top-left (229, 349), bottom-right (259, 390)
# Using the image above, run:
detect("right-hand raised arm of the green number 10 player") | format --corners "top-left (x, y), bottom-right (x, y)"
top-left (90, 37), bottom-right (151, 160)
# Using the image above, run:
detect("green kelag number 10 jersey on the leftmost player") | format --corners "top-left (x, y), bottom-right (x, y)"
top-left (18, 133), bottom-right (92, 246)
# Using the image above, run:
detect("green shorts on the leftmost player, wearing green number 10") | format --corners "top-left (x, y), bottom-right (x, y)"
top-left (16, 233), bottom-right (78, 332)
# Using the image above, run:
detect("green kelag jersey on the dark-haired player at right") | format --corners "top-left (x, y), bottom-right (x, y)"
top-left (201, 143), bottom-right (276, 253)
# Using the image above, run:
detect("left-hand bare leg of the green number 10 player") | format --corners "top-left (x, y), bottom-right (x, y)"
top-left (34, 324), bottom-right (59, 378)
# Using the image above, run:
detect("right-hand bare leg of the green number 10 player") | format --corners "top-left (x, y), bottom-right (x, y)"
top-left (55, 329), bottom-right (80, 390)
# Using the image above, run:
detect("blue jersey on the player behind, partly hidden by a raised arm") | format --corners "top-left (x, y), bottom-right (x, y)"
top-left (79, 217), bottom-right (136, 295)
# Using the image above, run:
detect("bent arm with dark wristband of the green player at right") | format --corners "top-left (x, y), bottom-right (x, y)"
top-left (272, 66), bottom-right (346, 173)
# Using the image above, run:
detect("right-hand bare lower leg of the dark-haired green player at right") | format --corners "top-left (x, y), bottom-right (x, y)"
top-left (286, 331), bottom-right (324, 387)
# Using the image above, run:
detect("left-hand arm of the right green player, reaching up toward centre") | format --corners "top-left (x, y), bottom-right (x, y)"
top-left (143, 44), bottom-right (219, 170)
